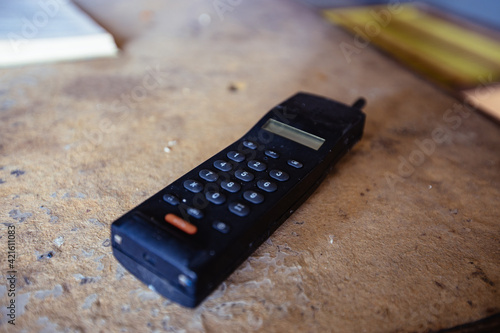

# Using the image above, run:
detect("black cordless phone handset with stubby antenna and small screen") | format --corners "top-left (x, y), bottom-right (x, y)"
top-left (111, 93), bottom-right (365, 307)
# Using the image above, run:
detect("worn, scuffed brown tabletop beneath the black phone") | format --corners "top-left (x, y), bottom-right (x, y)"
top-left (0, 0), bottom-right (500, 332)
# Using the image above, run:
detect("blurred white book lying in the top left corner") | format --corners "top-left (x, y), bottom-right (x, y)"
top-left (0, 0), bottom-right (118, 67)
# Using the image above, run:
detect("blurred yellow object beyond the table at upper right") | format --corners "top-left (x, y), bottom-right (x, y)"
top-left (324, 5), bottom-right (500, 90)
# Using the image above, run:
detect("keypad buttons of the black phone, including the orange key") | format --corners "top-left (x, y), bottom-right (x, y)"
top-left (163, 140), bottom-right (304, 234)
